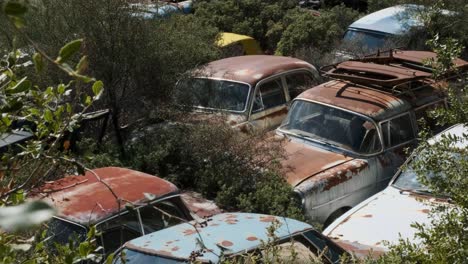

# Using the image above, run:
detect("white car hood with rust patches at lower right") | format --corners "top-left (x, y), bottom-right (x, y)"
top-left (323, 186), bottom-right (433, 257)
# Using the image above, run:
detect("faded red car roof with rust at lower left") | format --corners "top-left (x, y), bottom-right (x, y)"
top-left (31, 167), bottom-right (179, 225)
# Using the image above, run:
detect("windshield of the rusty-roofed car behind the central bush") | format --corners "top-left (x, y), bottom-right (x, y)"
top-left (178, 78), bottom-right (250, 112)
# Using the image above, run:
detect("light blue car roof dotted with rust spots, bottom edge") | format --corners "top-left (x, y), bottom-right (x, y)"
top-left (125, 213), bottom-right (312, 263)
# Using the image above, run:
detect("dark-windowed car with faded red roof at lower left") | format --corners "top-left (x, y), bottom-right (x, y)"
top-left (32, 167), bottom-right (215, 254)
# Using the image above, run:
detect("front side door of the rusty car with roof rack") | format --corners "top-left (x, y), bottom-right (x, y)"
top-left (376, 112), bottom-right (416, 190)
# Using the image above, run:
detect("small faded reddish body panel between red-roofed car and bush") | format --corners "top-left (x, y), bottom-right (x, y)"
top-left (180, 191), bottom-right (223, 218)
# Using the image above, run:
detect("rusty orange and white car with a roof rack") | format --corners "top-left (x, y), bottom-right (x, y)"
top-left (276, 50), bottom-right (468, 226)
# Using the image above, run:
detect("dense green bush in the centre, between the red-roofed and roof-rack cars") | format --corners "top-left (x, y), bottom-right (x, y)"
top-left (83, 120), bottom-right (303, 219)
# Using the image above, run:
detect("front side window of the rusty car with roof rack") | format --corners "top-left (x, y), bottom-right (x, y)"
top-left (382, 114), bottom-right (414, 148)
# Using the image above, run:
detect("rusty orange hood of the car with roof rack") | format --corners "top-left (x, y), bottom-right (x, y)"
top-left (281, 138), bottom-right (353, 187)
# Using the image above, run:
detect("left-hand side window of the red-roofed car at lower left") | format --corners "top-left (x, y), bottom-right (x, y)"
top-left (98, 210), bottom-right (142, 254)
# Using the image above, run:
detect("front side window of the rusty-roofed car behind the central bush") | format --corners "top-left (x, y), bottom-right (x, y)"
top-left (252, 78), bottom-right (286, 113)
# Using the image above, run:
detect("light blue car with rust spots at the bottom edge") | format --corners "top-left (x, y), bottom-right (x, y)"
top-left (114, 213), bottom-right (347, 264)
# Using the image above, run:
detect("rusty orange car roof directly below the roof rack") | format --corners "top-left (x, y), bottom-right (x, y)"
top-left (296, 80), bottom-right (444, 121)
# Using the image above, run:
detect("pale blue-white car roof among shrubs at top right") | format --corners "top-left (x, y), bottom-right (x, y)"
top-left (349, 5), bottom-right (423, 35)
